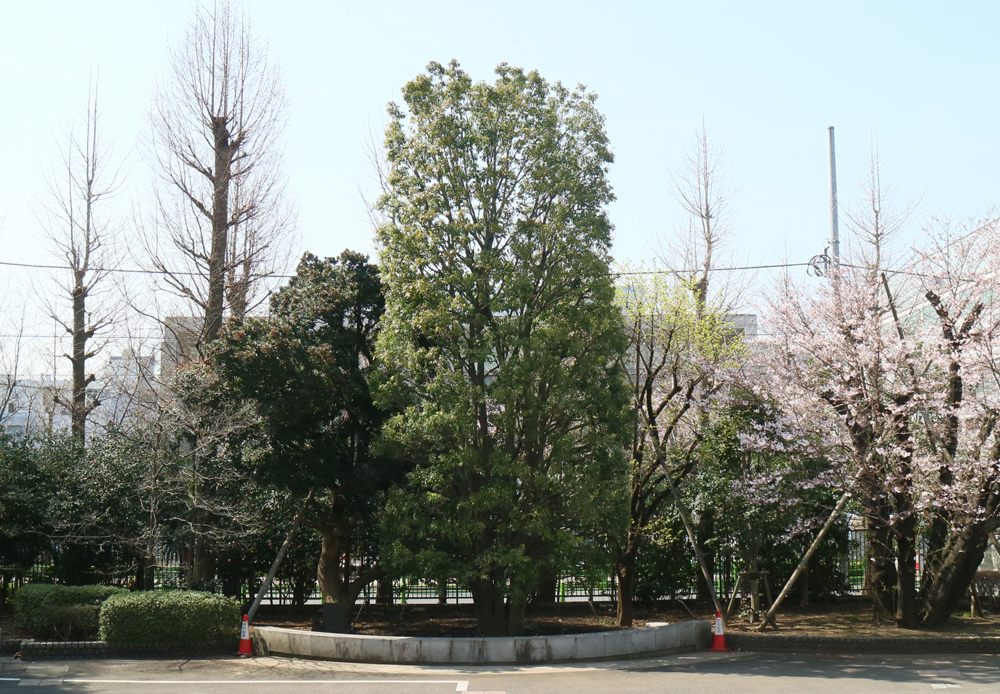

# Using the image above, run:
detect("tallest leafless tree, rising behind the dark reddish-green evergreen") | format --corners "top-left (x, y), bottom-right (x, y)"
top-left (144, 0), bottom-right (294, 346)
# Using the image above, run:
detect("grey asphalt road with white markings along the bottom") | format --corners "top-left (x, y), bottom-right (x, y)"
top-left (0, 653), bottom-right (1000, 694)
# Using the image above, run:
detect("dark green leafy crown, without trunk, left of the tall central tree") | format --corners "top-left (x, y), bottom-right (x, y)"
top-left (205, 251), bottom-right (385, 512)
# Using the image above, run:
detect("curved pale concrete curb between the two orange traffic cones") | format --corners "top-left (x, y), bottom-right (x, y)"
top-left (253, 620), bottom-right (712, 665)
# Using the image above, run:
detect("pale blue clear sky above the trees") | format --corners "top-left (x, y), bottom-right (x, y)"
top-left (0, 0), bottom-right (1000, 370)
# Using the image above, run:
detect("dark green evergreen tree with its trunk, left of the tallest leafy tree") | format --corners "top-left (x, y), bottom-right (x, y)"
top-left (203, 251), bottom-right (399, 631)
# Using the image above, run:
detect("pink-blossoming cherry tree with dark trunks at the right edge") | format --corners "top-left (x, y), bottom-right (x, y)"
top-left (760, 219), bottom-right (1000, 628)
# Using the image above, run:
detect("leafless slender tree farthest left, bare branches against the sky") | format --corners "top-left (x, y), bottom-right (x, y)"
top-left (43, 81), bottom-right (121, 441)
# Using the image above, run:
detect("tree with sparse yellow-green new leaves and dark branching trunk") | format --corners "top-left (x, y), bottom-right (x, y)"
top-left (610, 272), bottom-right (742, 626)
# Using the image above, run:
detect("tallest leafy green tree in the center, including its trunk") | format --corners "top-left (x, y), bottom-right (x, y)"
top-left (378, 62), bottom-right (627, 636)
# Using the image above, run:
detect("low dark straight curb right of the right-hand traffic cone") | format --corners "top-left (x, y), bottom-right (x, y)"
top-left (726, 632), bottom-right (1000, 655)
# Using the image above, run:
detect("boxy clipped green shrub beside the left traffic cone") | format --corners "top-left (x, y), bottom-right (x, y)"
top-left (99, 590), bottom-right (241, 646)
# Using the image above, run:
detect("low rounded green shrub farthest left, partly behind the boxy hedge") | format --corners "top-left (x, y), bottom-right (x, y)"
top-left (14, 583), bottom-right (128, 640)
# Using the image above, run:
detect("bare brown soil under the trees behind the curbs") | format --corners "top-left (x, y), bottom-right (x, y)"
top-left (255, 600), bottom-right (1000, 637)
